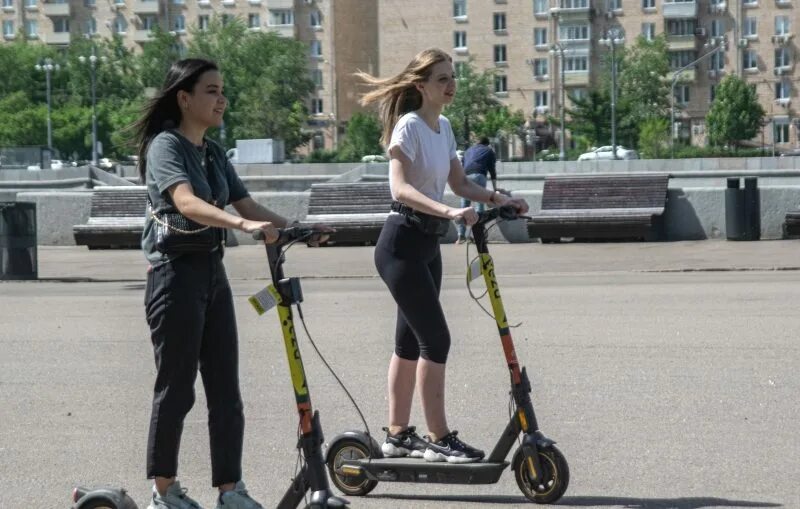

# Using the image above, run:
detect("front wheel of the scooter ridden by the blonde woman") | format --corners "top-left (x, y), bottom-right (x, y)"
top-left (512, 445), bottom-right (569, 504)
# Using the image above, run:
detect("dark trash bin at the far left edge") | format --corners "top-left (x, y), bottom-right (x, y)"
top-left (0, 202), bottom-right (37, 279)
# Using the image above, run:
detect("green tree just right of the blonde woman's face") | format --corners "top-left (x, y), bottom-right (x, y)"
top-left (444, 60), bottom-right (500, 147)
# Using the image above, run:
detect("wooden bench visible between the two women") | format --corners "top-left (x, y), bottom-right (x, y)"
top-left (303, 182), bottom-right (392, 245)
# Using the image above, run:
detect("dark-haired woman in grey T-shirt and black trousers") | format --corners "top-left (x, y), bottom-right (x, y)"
top-left (134, 59), bottom-right (282, 509)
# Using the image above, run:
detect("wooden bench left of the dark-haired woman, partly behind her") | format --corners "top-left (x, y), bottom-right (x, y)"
top-left (72, 186), bottom-right (147, 249)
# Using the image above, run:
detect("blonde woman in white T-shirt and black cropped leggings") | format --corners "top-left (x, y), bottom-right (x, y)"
top-left (359, 49), bottom-right (528, 463)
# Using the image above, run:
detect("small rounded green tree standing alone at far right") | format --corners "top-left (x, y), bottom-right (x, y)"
top-left (706, 74), bottom-right (764, 149)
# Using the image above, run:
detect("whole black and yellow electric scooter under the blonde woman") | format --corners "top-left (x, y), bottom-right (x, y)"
top-left (326, 207), bottom-right (569, 504)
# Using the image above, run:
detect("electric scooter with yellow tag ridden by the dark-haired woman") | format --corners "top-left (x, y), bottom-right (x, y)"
top-left (72, 227), bottom-right (349, 509)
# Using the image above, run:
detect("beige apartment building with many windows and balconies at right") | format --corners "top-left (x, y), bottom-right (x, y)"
top-left (378, 0), bottom-right (800, 152)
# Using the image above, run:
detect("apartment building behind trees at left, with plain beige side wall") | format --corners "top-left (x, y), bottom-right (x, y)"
top-left (0, 0), bottom-right (378, 148)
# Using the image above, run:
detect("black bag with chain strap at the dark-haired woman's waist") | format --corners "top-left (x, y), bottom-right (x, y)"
top-left (151, 207), bottom-right (225, 254)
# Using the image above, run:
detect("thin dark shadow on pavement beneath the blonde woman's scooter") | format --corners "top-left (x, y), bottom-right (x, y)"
top-left (369, 494), bottom-right (783, 509)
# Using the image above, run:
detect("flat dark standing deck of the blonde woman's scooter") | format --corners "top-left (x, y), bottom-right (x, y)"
top-left (342, 458), bottom-right (509, 484)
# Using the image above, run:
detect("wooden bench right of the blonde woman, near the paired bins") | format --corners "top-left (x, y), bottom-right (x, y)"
top-left (528, 174), bottom-right (669, 243)
